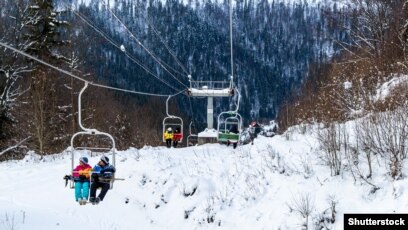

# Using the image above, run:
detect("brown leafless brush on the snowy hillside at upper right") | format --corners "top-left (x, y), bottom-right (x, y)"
top-left (278, 0), bottom-right (408, 129)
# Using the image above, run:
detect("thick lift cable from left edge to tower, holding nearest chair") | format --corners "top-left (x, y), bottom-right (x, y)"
top-left (0, 41), bottom-right (186, 97)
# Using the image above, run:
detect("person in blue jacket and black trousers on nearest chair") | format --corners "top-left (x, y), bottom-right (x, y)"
top-left (89, 156), bottom-right (116, 204)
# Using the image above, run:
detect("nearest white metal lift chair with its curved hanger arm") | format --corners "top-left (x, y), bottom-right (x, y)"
top-left (69, 82), bottom-right (116, 189)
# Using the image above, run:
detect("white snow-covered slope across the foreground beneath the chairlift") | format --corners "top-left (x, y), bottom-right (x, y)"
top-left (0, 125), bottom-right (408, 230)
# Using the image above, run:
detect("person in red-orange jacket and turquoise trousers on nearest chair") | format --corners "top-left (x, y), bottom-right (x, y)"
top-left (72, 157), bottom-right (92, 205)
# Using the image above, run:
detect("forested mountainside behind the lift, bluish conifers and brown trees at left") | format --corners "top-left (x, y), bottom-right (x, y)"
top-left (0, 0), bottom-right (402, 154)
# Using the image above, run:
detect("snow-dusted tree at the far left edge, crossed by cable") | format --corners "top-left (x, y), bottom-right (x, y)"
top-left (0, 0), bottom-right (32, 141)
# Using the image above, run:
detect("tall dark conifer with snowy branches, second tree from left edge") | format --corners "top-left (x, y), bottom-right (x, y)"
top-left (24, 0), bottom-right (70, 153)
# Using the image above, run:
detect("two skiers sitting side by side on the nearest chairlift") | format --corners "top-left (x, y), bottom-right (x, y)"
top-left (72, 156), bottom-right (116, 205)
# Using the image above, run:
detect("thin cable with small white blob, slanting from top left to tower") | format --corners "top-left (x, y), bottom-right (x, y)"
top-left (65, 3), bottom-right (179, 91)
